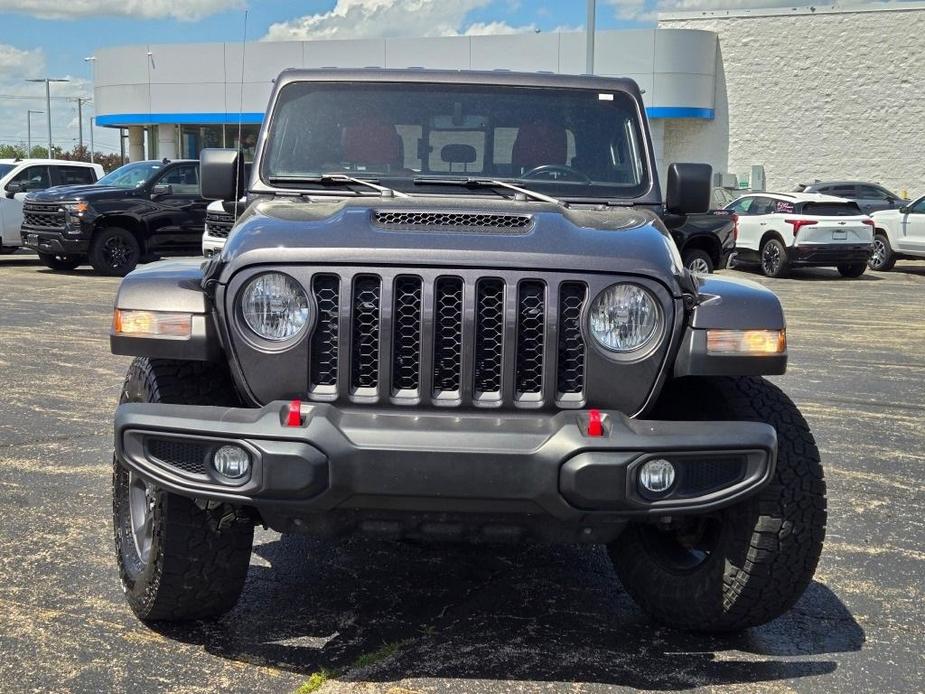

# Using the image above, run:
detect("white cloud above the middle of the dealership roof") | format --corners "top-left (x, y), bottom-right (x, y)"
top-left (260, 0), bottom-right (535, 41)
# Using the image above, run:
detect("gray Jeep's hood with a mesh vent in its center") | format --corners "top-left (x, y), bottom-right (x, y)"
top-left (213, 196), bottom-right (689, 294)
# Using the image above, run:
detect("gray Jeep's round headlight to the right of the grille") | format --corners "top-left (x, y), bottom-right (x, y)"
top-left (588, 284), bottom-right (659, 352)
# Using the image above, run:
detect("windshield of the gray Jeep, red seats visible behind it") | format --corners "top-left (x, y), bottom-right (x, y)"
top-left (261, 82), bottom-right (649, 198)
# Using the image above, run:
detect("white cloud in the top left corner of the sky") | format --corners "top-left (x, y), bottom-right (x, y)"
top-left (0, 0), bottom-right (244, 21)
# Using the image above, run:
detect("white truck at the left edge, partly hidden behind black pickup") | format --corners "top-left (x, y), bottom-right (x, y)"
top-left (0, 159), bottom-right (103, 253)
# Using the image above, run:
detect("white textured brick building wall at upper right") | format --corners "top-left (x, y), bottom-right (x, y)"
top-left (659, 4), bottom-right (925, 193)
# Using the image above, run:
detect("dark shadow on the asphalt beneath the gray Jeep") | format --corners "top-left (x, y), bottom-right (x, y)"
top-left (158, 534), bottom-right (865, 690)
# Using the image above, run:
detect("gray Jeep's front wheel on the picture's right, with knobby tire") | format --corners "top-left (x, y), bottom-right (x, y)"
top-left (609, 378), bottom-right (826, 632)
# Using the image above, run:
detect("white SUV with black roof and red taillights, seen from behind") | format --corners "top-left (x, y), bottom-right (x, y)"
top-left (726, 193), bottom-right (874, 277)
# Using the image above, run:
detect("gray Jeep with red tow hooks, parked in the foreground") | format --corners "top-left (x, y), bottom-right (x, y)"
top-left (111, 69), bottom-right (826, 631)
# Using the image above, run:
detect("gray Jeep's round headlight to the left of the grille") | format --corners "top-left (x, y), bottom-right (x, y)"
top-left (241, 272), bottom-right (308, 342)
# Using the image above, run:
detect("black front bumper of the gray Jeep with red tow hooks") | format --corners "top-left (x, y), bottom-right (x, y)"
top-left (115, 402), bottom-right (777, 532)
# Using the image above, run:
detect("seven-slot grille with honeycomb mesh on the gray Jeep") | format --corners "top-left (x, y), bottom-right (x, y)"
top-left (309, 271), bottom-right (588, 407)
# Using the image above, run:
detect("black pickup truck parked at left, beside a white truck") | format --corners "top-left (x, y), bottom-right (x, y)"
top-left (22, 159), bottom-right (208, 276)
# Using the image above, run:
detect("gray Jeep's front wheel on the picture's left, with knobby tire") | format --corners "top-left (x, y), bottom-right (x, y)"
top-left (112, 358), bottom-right (254, 621)
